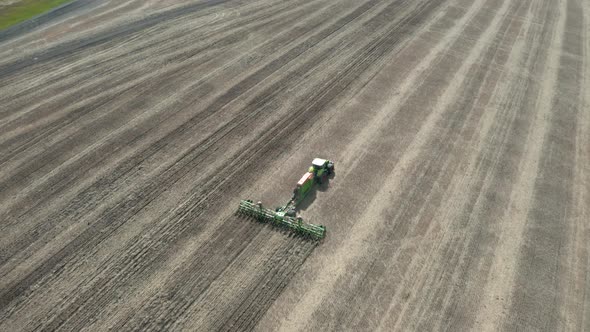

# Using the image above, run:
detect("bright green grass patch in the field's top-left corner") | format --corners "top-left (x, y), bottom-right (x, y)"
top-left (0, 0), bottom-right (71, 30)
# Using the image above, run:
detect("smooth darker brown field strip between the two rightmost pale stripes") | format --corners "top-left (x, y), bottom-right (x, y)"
top-left (504, 1), bottom-right (584, 330)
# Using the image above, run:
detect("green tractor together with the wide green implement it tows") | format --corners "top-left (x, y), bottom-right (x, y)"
top-left (238, 158), bottom-right (334, 240)
